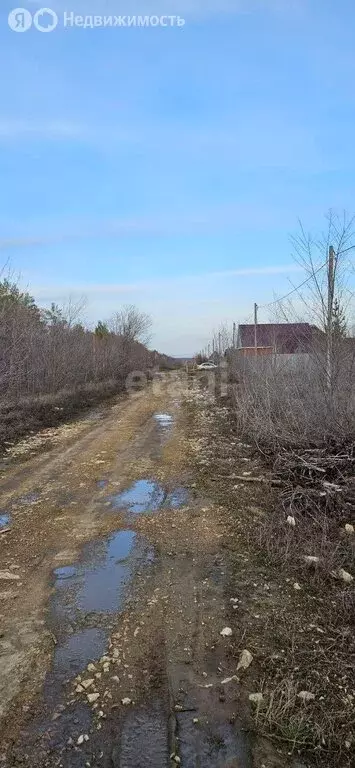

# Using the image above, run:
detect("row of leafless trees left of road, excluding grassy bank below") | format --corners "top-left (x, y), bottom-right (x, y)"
top-left (0, 279), bottom-right (175, 399)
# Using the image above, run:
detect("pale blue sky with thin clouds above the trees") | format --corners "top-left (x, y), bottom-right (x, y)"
top-left (0, 0), bottom-right (355, 354)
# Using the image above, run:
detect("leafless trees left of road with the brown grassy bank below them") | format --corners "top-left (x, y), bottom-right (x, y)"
top-left (0, 276), bottom-right (174, 450)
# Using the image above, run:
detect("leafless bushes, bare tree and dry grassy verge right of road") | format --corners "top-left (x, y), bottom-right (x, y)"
top-left (192, 215), bottom-right (355, 768)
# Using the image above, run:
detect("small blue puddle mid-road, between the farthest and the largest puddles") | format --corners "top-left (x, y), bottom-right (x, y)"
top-left (110, 480), bottom-right (189, 515)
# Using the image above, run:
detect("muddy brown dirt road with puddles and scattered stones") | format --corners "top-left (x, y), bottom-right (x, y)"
top-left (0, 376), bottom-right (253, 768)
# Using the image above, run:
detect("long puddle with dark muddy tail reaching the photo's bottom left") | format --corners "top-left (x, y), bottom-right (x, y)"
top-left (17, 531), bottom-right (154, 768)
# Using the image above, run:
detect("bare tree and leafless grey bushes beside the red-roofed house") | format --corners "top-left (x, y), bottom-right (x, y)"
top-left (228, 212), bottom-right (355, 451)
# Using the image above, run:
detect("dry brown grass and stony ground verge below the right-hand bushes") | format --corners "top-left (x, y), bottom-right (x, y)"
top-left (189, 388), bottom-right (355, 768)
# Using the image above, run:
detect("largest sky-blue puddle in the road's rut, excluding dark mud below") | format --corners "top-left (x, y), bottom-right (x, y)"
top-left (50, 531), bottom-right (154, 677)
